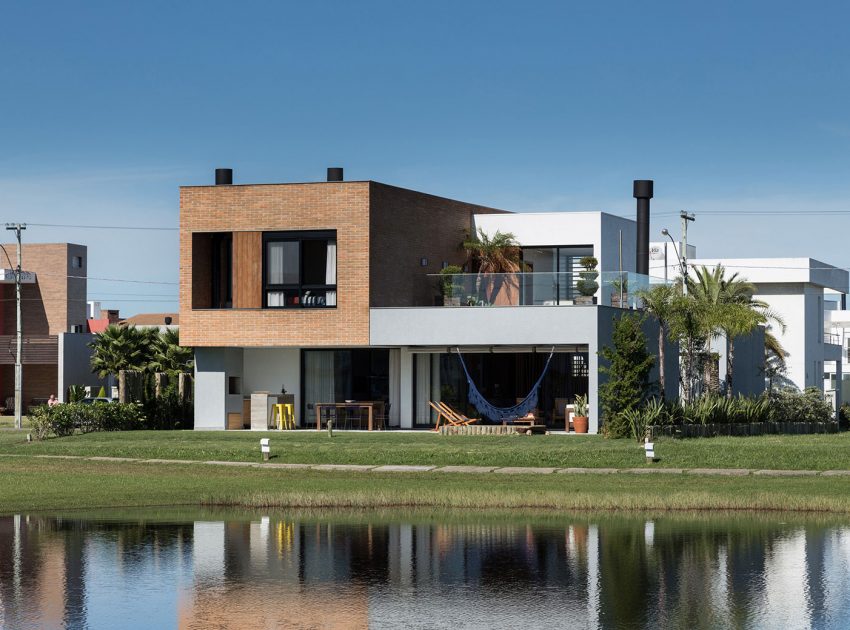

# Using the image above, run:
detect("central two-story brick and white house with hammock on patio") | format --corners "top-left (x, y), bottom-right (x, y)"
top-left (180, 169), bottom-right (676, 432)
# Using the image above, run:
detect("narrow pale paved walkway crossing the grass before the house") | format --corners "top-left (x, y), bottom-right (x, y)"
top-left (0, 453), bottom-right (850, 477)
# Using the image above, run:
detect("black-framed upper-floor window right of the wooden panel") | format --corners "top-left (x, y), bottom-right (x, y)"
top-left (263, 232), bottom-right (336, 308)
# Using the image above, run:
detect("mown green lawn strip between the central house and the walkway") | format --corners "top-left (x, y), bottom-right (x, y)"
top-left (0, 430), bottom-right (850, 470)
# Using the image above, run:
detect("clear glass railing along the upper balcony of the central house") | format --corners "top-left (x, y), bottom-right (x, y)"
top-left (427, 271), bottom-right (665, 308)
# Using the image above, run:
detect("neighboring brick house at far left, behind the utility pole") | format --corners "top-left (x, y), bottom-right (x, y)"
top-left (0, 243), bottom-right (96, 413)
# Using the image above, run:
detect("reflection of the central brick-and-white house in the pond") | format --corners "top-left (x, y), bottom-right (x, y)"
top-left (179, 519), bottom-right (590, 628)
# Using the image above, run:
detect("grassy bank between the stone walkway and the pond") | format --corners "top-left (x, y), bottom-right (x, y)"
top-left (0, 458), bottom-right (850, 514)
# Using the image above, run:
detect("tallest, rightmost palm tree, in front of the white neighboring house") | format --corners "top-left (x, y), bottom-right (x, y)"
top-left (688, 265), bottom-right (785, 398)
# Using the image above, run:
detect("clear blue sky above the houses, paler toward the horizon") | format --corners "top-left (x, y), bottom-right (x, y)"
top-left (0, 0), bottom-right (850, 315)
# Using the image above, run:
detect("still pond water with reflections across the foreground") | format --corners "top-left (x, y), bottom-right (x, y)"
top-left (0, 509), bottom-right (850, 630)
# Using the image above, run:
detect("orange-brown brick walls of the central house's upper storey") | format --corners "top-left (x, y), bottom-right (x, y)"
top-left (180, 182), bottom-right (500, 347)
